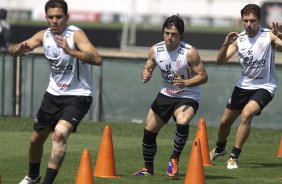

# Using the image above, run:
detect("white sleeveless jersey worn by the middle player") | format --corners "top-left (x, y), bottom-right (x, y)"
top-left (154, 41), bottom-right (200, 101)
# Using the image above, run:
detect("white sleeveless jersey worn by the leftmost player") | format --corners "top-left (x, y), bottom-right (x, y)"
top-left (43, 26), bottom-right (93, 96)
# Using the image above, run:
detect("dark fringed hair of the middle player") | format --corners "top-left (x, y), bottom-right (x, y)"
top-left (162, 15), bottom-right (184, 39)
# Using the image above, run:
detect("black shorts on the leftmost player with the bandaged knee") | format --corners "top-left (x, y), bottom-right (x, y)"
top-left (34, 92), bottom-right (92, 132)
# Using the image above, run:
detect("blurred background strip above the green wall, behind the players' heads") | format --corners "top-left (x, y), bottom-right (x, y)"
top-left (0, 0), bottom-right (282, 49)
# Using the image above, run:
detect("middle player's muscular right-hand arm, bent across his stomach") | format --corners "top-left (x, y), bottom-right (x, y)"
top-left (173, 47), bottom-right (208, 87)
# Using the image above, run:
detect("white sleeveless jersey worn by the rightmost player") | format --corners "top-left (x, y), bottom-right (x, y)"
top-left (237, 28), bottom-right (277, 94)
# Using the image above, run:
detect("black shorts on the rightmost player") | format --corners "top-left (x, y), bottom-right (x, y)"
top-left (226, 86), bottom-right (273, 115)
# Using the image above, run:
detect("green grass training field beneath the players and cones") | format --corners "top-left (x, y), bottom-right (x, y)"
top-left (0, 117), bottom-right (282, 184)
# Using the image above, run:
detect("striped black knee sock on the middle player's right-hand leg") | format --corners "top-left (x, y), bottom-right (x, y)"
top-left (171, 124), bottom-right (189, 160)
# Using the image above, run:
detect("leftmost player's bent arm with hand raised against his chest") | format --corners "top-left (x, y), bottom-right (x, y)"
top-left (60, 31), bottom-right (102, 65)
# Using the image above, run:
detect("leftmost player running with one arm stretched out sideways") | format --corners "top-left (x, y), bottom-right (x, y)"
top-left (9, 0), bottom-right (102, 184)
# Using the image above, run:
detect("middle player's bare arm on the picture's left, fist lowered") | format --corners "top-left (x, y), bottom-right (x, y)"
top-left (141, 47), bottom-right (156, 83)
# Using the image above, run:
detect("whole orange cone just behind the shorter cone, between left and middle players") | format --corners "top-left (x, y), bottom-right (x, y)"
top-left (93, 125), bottom-right (118, 178)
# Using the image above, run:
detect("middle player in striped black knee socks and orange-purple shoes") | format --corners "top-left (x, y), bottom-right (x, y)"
top-left (133, 15), bottom-right (208, 178)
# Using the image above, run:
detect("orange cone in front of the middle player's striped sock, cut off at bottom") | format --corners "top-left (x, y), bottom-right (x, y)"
top-left (184, 139), bottom-right (206, 184)
